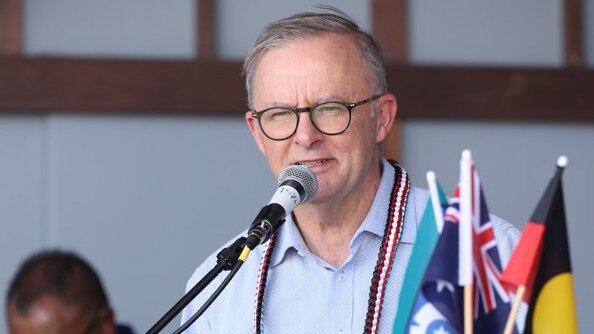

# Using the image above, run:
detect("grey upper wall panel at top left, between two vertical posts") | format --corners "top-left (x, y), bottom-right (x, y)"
top-left (23, 0), bottom-right (195, 58)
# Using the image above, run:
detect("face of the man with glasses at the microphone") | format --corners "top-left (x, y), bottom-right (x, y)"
top-left (246, 34), bottom-right (396, 203)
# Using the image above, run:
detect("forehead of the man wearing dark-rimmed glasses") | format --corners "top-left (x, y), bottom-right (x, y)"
top-left (253, 33), bottom-right (369, 105)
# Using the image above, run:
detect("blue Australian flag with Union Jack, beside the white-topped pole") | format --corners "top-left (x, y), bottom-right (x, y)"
top-left (408, 165), bottom-right (517, 334)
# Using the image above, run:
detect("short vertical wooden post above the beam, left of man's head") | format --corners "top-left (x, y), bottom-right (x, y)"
top-left (196, 0), bottom-right (217, 59)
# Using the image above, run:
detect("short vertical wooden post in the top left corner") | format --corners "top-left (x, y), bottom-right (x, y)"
top-left (0, 0), bottom-right (23, 55)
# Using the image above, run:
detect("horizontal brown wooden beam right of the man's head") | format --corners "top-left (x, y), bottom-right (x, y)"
top-left (387, 65), bottom-right (594, 122)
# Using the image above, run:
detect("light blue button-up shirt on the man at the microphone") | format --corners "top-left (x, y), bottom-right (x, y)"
top-left (182, 160), bottom-right (519, 334)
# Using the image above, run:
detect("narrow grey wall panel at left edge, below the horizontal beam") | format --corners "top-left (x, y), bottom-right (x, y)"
top-left (0, 115), bottom-right (47, 333)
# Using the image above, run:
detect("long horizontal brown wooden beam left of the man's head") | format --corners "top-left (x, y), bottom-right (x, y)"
top-left (0, 57), bottom-right (247, 114)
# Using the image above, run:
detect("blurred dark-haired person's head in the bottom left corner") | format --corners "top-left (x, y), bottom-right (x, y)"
top-left (6, 250), bottom-right (133, 334)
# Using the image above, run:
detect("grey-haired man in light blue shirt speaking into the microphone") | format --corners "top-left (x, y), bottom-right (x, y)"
top-left (182, 8), bottom-right (518, 333)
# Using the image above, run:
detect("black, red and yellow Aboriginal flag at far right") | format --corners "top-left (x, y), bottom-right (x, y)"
top-left (501, 161), bottom-right (577, 334)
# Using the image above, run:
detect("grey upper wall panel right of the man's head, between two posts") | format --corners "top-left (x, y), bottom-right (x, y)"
top-left (409, 0), bottom-right (563, 66)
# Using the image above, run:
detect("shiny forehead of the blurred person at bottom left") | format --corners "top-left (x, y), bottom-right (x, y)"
top-left (8, 296), bottom-right (86, 334)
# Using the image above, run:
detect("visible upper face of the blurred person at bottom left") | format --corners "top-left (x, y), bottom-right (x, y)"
top-left (8, 296), bottom-right (115, 334)
